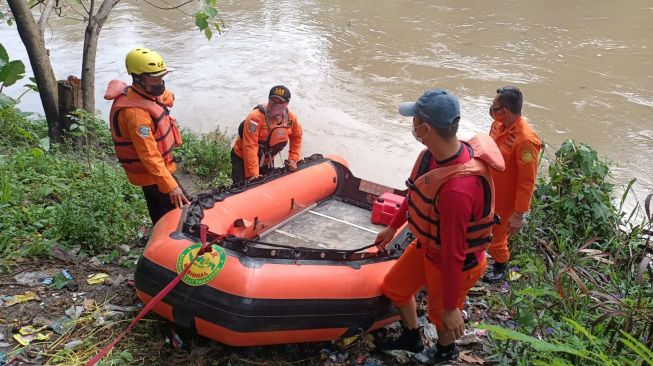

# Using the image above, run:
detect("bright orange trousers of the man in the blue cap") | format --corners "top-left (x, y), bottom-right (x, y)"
top-left (381, 241), bottom-right (487, 331)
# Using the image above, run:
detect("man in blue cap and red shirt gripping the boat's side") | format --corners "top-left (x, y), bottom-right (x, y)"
top-left (377, 89), bottom-right (503, 365)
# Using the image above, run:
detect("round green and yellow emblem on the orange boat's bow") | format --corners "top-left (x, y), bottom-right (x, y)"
top-left (177, 243), bottom-right (227, 286)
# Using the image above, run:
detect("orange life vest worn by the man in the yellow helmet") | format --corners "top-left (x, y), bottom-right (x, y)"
top-left (105, 80), bottom-right (182, 173)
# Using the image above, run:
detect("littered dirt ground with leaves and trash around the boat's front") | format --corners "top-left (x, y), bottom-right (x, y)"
top-left (0, 248), bottom-right (509, 366)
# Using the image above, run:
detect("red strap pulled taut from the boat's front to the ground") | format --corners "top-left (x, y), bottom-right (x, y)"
top-left (86, 224), bottom-right (224, 366)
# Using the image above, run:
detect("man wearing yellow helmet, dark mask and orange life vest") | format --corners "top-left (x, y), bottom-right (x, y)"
top-left (104, 47), bottom-right (188, 225)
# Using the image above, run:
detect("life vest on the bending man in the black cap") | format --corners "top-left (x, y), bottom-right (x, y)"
top-left (238, 104), bottom-right (293, 167)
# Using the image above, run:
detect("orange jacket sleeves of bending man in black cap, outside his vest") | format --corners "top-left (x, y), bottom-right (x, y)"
top-left (234, 105), bottom-right (302, 178)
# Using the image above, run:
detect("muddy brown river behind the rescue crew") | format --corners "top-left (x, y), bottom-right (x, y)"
top-left (0, 0), bottom-right (653, 209)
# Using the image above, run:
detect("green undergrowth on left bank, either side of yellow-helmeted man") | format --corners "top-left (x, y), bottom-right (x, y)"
top-left (0, 107), bottom-right (230, 268)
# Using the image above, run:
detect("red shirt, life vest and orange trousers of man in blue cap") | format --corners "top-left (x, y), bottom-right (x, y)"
top-left (381, 134), bottom-right (504, 331)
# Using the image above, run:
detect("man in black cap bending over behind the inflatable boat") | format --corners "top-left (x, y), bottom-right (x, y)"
top-left (231, 85), bottom-right (302, 183)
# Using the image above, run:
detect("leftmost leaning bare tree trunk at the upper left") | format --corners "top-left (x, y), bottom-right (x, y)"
top-left (7, 0), bottom-right (61, 142)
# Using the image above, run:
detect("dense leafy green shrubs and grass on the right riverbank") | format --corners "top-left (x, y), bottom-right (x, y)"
top-left (486, 141), bottom-right (653, 365)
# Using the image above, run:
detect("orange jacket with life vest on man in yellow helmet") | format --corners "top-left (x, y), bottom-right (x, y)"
top-left (104, 80), bottom-right (181, 193)
